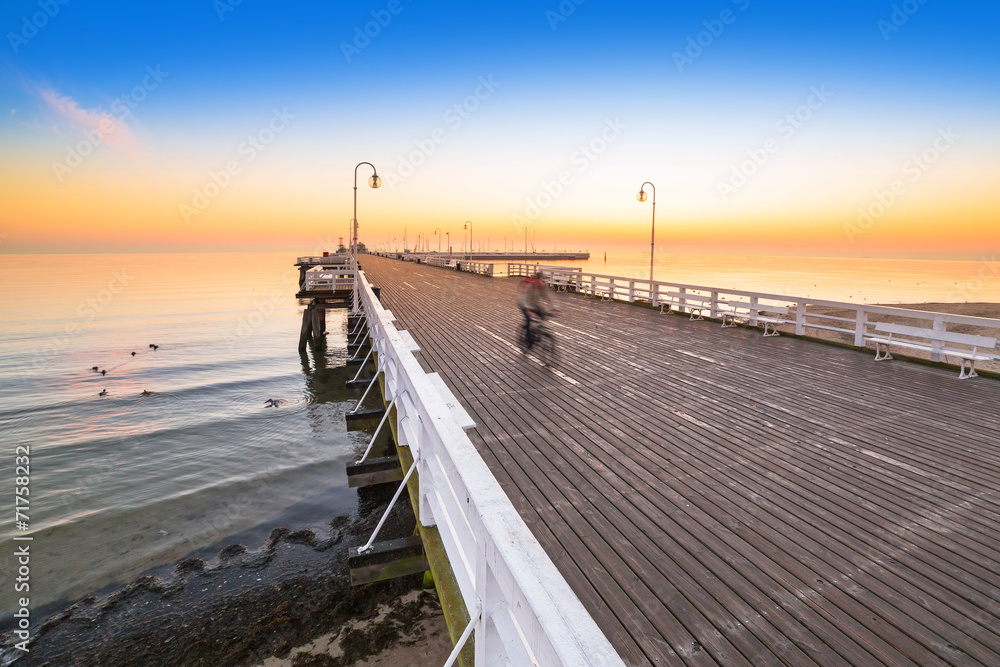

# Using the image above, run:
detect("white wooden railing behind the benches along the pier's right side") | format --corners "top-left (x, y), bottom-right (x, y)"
top-left (507, 263), bottom-right (1000, 361)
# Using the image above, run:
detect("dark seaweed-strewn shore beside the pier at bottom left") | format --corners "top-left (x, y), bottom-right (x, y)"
top-left (0, 482), bottom-right (451, 667)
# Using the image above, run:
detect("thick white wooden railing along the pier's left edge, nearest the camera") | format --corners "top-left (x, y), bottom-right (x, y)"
top-left (360, 271), bottom-right (623, 667)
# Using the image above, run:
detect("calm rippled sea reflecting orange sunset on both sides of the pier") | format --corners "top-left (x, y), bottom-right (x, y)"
top-left (0, 252), bottom-right (1000, 614)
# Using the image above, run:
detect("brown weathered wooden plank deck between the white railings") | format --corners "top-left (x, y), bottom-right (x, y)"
top-left (362, 256), bottom-right (1000, 665)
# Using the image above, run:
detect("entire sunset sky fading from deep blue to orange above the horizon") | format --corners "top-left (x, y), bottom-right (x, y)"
top-left (0, 0), bottom-right (1000, 256)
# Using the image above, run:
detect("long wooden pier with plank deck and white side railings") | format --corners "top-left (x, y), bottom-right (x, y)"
top-left (296, 256), bottom-right (1000, 665)
